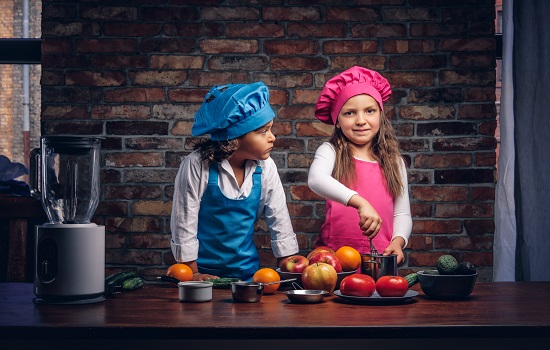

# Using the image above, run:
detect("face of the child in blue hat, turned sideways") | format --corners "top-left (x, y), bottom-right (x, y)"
top-left (235, 120), bottom-right (276, 160)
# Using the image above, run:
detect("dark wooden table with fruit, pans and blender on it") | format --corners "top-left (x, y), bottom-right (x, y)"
top-left (0, 282), bottom-right (550, 350)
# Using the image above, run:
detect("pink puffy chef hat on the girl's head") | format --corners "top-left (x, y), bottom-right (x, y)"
top-left (315, 66), bottom-right (391, 125)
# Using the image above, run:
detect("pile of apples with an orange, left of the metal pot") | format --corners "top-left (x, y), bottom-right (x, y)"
top-left (280, 246), bottom-right (361, 293)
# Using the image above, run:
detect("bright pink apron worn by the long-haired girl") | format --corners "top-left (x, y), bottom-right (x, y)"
top-left (315, 159), bottom-right (394, 254)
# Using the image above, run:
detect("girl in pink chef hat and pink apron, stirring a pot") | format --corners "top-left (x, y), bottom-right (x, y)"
top-left (308, 66), bottom-right (412, 264)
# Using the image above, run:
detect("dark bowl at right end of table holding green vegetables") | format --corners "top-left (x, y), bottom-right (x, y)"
top-left (417, 270), bottom-right (477, 299)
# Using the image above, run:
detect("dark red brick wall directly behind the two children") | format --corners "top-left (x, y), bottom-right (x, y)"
top-left (42, 0), bottom-right (496, 280)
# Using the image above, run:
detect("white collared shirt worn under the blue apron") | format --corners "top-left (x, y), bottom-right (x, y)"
top-left (170, 151), bottom-right (298, 262)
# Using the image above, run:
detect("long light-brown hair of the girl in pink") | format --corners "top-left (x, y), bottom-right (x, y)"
top-left (329, 112), bottom-right (403, 198)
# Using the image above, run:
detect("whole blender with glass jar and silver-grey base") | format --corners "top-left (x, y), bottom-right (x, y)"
top-left (30, 136), bottom-right (105, 304)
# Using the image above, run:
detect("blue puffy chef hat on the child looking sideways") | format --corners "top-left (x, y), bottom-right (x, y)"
top-left (191, 82), bottom-right (275, 141)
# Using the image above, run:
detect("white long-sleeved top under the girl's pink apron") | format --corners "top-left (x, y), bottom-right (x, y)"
top-left (307, 142), bottom-right (412, 246)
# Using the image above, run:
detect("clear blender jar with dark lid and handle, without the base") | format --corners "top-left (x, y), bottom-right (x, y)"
top-left (30, 136), bottom-right (101, 224)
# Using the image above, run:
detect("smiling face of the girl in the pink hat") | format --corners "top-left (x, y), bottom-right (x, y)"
top-left (336, 94), bottom-right (381, 146)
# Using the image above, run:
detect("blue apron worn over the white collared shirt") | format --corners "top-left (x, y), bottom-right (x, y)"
top-left (197, 164), bottom-right (262, 281)
